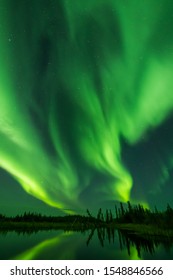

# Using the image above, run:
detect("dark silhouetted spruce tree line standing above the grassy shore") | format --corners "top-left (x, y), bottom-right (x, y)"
top-left (0, 201), bottom-right (173, 228)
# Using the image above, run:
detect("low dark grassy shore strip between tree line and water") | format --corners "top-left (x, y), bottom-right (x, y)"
top-left (0, 221), bottom-right (173, 238)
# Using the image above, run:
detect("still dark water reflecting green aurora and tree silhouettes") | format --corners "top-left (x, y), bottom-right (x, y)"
top-left (0, 229), bottom-right (173, 260)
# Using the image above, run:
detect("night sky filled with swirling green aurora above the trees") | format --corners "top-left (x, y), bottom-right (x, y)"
top-left (0, 0), bottom-right (173, 213)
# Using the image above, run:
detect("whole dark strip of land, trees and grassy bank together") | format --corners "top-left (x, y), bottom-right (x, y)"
top-left (0, 202), bottom-right (173, 239)
